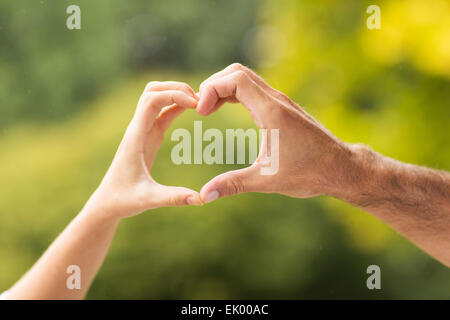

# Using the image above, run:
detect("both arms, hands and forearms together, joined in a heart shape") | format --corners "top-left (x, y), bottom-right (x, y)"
top-left (7, 64), bottom-right (450, 299)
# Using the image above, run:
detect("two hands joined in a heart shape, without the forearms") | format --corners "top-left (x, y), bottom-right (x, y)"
top-left (89, 64), bottom-right (351, 218)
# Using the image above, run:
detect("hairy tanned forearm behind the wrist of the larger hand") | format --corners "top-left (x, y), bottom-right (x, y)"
top-left (330, 145), bottom-right (450, 266)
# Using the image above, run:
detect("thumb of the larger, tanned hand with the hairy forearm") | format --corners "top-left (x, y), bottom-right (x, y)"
top-left (200, 166), bottom-right (257, 203)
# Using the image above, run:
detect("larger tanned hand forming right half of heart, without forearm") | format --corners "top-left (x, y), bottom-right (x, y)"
top-left (197, 64), bottom-right (352, 202)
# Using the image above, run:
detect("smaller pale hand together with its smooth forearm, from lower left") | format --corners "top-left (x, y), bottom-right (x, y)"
top-left (6, 82), bottom-right (201, 299)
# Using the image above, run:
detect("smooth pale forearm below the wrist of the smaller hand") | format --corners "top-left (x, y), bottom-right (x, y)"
top-left (7, 203), bottom-right (119, 299)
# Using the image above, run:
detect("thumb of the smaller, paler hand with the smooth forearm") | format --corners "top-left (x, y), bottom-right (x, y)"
top-left (151, 185), bottom-right (202, 208)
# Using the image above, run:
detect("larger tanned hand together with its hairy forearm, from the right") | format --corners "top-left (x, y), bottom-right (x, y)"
top-left (197, 64), bottom-right (450, 266)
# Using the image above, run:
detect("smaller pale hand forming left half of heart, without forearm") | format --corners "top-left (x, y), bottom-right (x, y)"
top-left (86, 82), bottom-right (202, 218)
